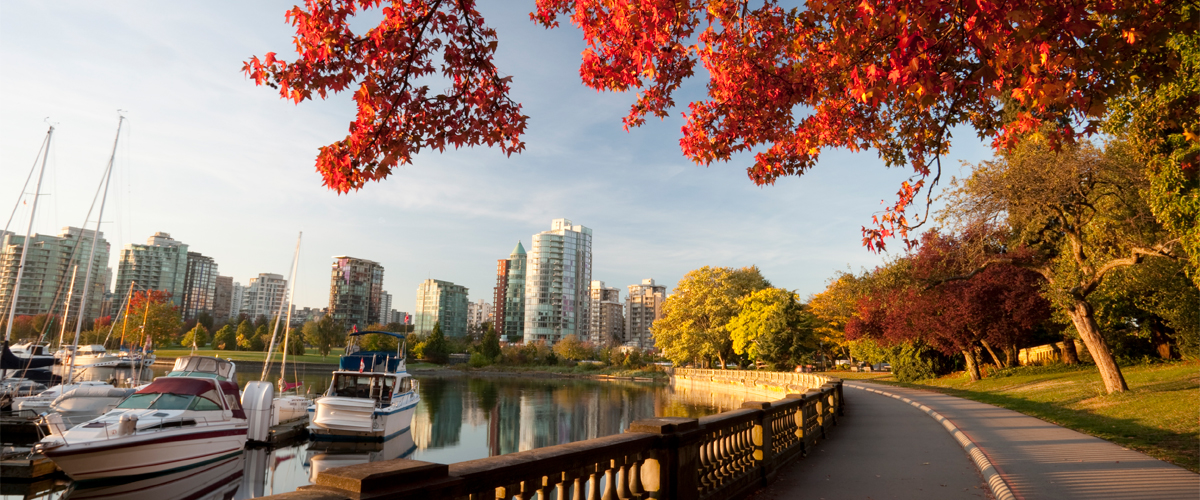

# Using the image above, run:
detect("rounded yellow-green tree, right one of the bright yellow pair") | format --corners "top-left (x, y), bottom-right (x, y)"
top-left (728, 288), bottom-right (817, 369)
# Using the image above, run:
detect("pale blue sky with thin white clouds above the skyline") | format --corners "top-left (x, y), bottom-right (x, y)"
top-left (0, 0), bottom-right (991, 312)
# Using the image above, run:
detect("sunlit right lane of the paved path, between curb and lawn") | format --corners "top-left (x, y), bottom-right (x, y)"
top-left (844, 381), bottom-right (1200, 500)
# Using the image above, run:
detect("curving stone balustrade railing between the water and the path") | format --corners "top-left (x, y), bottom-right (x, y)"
top-left (272, 371), bottom-right (844, 500)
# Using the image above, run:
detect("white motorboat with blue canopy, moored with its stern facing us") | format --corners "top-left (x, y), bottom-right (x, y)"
top-left (308, 332), bottom-right (421, 441)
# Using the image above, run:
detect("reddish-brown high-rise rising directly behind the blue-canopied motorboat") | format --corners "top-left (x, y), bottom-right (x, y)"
top-left (329, 255), bottom-right (383, 330)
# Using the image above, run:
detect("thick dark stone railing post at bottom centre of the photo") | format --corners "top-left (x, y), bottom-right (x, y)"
top-left (625, 417), bottom-right (701, 500)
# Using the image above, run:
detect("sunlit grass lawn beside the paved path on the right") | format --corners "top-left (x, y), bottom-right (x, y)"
top-left (876, 361), bottom-right (1200, 472)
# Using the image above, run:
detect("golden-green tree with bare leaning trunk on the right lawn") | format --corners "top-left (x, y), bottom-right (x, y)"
top-left (949, 138), bottom-right (1180, 393)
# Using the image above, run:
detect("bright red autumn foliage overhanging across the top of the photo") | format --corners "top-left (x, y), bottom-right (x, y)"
top-left (245, 0), bottom-right (1196, 248)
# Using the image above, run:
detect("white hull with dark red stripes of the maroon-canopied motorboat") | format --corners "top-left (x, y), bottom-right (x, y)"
top-left (42, 426), bottom-right (246, 481)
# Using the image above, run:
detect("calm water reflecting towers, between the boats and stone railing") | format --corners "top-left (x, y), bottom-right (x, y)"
top-left (2, 363), bottom-right (738, 500)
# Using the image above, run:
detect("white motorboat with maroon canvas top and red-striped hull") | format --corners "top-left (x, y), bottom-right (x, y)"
top-left (37, 371), bottom-right (247, 481)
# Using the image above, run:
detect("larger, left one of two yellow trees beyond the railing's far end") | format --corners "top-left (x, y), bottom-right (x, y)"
top-left (650, 266), bottom-right (770, 368)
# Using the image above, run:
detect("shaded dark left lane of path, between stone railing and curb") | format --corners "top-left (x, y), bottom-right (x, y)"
top-left (755, 378), bottom-right (991, 500)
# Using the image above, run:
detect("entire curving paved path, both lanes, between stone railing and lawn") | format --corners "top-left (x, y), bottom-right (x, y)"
top-left (758, 381), bottom-right (1200, 500)
